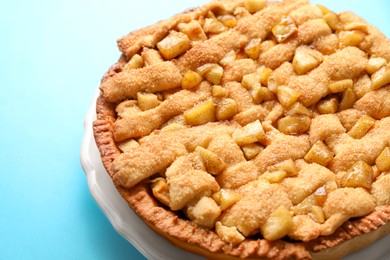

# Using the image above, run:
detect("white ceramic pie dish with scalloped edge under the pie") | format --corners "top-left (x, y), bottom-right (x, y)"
top-left (80, 90), bottom-right (390, 260)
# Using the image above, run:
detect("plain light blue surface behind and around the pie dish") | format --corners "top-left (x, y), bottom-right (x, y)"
top-left (0, 0), bottom-right (390, 259)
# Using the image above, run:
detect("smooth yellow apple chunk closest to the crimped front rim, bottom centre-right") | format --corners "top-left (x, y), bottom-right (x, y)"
top-left (261, 206), bottom-right (293, 241)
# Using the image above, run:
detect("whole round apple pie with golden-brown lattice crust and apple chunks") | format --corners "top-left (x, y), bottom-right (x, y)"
top-left (94, 1), bottom-right (390, 259)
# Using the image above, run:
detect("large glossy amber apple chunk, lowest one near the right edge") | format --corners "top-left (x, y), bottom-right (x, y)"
top-left (340, 161), bottom-right (373, 189)
